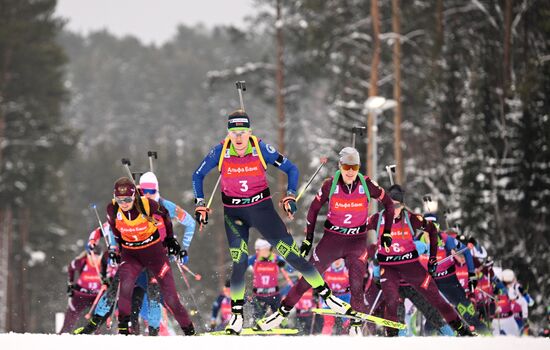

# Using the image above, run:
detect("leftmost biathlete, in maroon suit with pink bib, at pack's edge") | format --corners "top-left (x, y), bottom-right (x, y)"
top-left (60, 252), bottom-right (106, 333)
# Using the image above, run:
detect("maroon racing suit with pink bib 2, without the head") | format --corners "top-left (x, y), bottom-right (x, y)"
top-left (281, 173), bottom-right (393, 312)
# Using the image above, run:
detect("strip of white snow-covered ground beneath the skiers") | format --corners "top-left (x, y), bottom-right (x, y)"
top-left (0, 333), bottom-right (550, 350)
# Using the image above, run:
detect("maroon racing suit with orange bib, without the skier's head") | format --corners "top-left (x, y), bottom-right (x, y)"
top-left (107, 197), bottom-right (192, 329)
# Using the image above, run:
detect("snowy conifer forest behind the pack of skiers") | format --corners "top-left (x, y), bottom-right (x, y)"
top-left (0, 0), bottom-right (550, 332)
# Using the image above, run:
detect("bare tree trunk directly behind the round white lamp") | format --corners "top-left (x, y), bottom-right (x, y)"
top-left (367, 0), bottom-right (380, 189)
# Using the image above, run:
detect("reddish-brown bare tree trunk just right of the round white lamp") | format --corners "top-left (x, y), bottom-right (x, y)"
top-left (392, 0), bottom-right (405, 184)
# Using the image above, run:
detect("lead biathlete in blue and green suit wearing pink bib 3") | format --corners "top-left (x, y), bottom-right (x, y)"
top-left (193, 110), bottom-right (352, 334)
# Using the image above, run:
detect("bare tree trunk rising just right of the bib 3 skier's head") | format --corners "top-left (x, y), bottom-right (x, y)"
top-left (275, 0), bottom-right (286, 196)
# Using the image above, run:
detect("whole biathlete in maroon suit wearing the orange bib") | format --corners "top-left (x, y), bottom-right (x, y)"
top-left (107, 177), bottom-right (195, 335)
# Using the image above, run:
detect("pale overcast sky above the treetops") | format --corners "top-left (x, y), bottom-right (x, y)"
top-left (56, 0), bottom-right (254, 44)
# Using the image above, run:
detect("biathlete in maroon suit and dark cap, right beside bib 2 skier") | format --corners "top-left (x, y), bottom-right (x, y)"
top-left (374, 184), bottom-right (473, 336)
